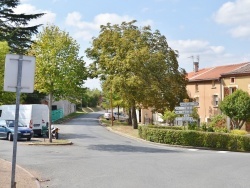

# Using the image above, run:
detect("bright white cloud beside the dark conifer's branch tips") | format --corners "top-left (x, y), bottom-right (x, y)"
top-left (14, 4), bottom-right (56, 25)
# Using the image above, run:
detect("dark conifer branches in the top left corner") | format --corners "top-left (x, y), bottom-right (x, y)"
top-left (0, 0), bottom-right (44, 54)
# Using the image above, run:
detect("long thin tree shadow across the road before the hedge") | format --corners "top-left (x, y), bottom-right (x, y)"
top-left (88, 144), bottom-right (180, 153)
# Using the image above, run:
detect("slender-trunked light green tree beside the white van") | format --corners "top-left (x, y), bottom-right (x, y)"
top-left (30, 25), bottom-right (87, 142)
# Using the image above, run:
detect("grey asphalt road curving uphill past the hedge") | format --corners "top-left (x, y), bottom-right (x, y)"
top-left (0, 113), bottom-right (250, 188)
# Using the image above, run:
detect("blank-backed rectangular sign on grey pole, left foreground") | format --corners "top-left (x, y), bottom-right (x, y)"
top-left (4, 54), bottom-right (35, 188)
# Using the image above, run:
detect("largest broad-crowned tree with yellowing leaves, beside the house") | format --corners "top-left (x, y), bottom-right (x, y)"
top-left (86, 21), bottom-right (187, 128)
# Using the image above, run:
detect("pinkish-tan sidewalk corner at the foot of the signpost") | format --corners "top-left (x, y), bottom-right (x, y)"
top-left (0, 159), bottom-right (40, 188)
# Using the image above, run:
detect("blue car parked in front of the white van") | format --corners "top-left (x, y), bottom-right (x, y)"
top-left (0, 120), bottom-right (34, 141)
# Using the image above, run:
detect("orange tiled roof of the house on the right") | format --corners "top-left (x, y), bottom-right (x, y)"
top-left (187, 63), bottom-right (250, 82)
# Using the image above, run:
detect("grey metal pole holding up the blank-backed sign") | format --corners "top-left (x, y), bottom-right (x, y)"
top-left (11, 55), bottom-right (23, 188)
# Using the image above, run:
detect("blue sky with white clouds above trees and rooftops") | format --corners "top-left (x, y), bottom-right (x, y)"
top-left (18, 0), bottom-right (250, 89)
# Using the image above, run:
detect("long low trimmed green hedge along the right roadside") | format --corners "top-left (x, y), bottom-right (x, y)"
top-left (138, 126), bottom-right (250, 151)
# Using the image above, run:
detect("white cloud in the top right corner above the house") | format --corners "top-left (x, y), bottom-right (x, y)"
top-left (214, 0), bottom-right (250, 38)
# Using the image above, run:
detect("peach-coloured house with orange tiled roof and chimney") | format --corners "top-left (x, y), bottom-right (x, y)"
top-left (187, 62), bottom-right (250, 122)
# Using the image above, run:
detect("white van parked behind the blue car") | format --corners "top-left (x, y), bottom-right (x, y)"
top-left (0, 104), bottom-right (49, 135)
